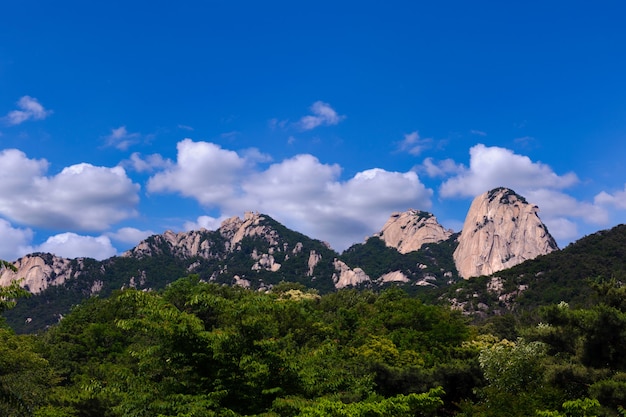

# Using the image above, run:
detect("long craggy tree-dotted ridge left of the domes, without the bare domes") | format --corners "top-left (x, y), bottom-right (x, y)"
top-left (0, 212), bottom-right (458, 332)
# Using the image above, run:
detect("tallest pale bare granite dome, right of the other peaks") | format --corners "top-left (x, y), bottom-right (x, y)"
top-left (453, 188), bottom-right (558, 279)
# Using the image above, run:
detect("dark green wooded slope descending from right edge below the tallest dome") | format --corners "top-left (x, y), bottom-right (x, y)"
top-left (438, 224), bottom-right (626, 317)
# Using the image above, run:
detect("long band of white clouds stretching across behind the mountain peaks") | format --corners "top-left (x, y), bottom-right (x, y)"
top-left (0, 138), bottom-right (626, 259)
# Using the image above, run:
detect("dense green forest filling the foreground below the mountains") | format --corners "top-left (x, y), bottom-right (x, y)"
top-left (0, 264), bottom-right (626, 417)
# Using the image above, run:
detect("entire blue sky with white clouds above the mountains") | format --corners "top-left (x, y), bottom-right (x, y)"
top-left (0, 0), bottom-right (626, 261)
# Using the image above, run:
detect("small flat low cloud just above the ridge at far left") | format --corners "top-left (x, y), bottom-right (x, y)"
top-left (36, 233), bottom-right (117, 260)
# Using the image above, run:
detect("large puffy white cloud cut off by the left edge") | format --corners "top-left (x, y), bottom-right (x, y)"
top-left (0, 149), bottom-right (139, 230)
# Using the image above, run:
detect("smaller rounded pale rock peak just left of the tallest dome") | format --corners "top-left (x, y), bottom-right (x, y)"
top-left (376, 209), bottom-right (453, 254)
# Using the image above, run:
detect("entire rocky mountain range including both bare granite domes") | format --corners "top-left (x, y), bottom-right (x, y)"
top-left (0, 188), bottom-right (584, 332)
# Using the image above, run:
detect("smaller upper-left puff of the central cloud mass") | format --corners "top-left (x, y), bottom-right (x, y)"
top-left (148, 139), bottom-right (247, 206)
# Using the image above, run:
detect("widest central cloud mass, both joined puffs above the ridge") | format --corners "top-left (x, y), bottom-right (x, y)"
top-left (148, 139), bottom-right (432, 250)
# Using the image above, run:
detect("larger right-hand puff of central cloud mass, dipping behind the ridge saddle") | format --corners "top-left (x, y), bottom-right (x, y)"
top-left (240, 155), bottom-right (432, 250)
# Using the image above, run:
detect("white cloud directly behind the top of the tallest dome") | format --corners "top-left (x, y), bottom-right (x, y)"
top-left (441, 144), bottom-right (578, 197)
